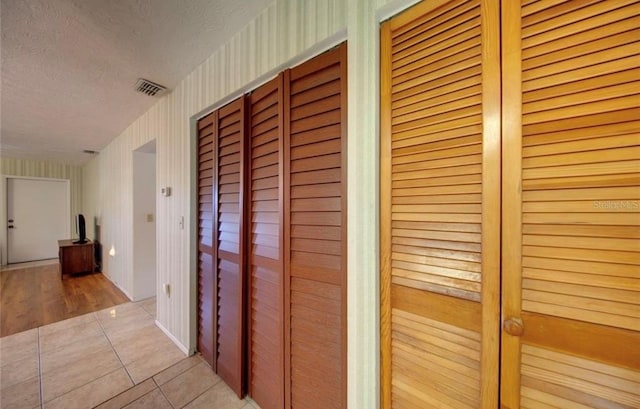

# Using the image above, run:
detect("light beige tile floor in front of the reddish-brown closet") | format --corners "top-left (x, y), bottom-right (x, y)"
top-left (0, 298), bottom-right (258, 409)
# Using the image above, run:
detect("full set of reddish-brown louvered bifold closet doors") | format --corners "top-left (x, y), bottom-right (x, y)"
top-left (198, 44), bottom-right (347, 409)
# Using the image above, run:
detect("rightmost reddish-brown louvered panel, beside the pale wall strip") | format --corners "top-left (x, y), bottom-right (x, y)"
top-left (285, 45), bottom-right (347, 409)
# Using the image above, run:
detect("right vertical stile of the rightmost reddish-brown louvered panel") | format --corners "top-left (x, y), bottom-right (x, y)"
top-left (340, 42), bottom-right (349, 408)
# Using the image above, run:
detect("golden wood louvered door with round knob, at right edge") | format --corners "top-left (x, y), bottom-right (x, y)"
top-left (502, 0), bottom-right (640, 409)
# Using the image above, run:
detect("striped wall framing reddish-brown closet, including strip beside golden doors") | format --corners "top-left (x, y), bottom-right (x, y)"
top-left (85, 0), bottom-right (424, 408)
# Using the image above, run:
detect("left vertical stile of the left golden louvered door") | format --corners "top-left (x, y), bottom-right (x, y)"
top-left (380, 21), bottom-right (391, 409)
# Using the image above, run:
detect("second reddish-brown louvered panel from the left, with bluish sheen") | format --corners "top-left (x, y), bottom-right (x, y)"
top-left (214, 97), bottom-right (246, 397)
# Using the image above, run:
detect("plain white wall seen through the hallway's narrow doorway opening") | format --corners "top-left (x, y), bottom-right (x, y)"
top-left (132, 152), bottom-right (157, 301)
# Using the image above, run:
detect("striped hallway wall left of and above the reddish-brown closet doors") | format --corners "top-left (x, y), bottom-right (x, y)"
top-left (85, 0), bottom-right (346, 351)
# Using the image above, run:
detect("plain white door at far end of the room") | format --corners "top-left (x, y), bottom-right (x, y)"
top-left (7, 178), bottom-right (71, 263)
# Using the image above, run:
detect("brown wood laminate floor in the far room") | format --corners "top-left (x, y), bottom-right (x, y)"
top-left (0, 262), bottom-right (129, 337)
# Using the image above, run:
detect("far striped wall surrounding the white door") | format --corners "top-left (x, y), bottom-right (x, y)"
top-left (0, 158), bottom-right (84, 263)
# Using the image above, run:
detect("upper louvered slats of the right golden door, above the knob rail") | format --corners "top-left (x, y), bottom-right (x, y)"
top-left (522, 2), bottom-right (640, 336)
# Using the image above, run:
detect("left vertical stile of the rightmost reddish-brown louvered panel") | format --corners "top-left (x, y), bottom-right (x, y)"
top-left (282, 69), bottom-right (291, 409)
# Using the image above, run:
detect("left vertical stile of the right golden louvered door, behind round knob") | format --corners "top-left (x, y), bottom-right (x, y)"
top-left (500, 0), bottom-right (526, 409)
